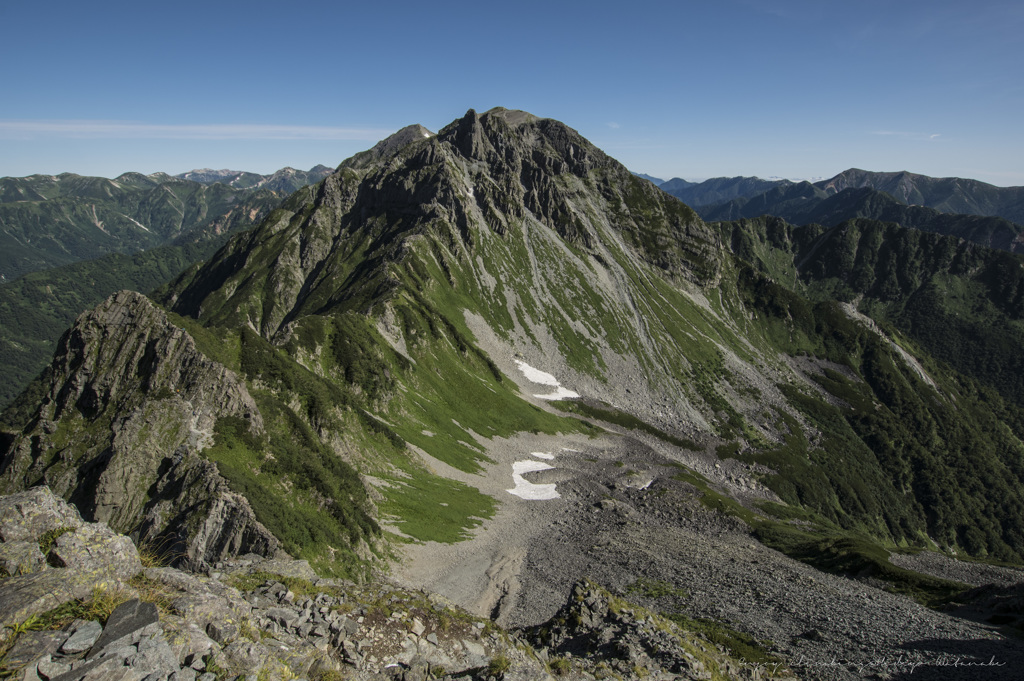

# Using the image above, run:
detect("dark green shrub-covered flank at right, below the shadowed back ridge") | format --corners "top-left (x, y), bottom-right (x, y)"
top-left (737, 254), bottom-right (1024, 561)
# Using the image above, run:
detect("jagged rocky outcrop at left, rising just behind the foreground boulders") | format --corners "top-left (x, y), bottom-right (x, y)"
top-left (0, 291), bottom-right (278, 565)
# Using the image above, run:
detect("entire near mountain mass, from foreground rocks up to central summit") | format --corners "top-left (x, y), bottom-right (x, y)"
top-left (0, 109), bottom-right (1024, 679)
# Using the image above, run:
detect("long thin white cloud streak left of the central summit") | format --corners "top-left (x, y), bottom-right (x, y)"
top-left (0, 121), bottom-right (393, 141)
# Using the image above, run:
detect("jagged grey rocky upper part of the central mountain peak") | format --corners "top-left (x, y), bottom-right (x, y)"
top-left (161, 109), bottom-right (720, 338)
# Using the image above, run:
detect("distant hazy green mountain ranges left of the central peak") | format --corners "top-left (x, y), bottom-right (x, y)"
top-left (0, 166), bottom-right (332, 405)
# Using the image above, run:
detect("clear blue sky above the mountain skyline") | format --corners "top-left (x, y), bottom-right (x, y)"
top-left (0, 0), bottom-right (1024, 185)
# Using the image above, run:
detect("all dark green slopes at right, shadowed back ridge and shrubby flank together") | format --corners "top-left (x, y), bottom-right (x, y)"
top-left (719, 218), bottom-right (1024, 560)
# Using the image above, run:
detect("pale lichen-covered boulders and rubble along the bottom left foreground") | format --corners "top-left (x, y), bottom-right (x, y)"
top-left (0, 487), bottom-right (756, 681)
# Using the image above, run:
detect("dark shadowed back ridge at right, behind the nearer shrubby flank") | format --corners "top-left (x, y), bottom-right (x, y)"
top-left (720, 218), bottom-right (1024, 406)
